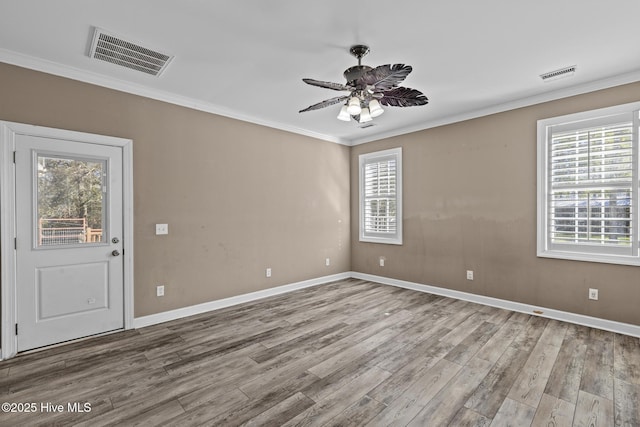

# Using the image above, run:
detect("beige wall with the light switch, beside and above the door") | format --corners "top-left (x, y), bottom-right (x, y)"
top-left (0, 63), bottom-right (350, 317)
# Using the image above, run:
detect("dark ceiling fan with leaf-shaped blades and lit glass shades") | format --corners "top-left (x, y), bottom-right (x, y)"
top-left (299, 44), bottom-right (429, 123)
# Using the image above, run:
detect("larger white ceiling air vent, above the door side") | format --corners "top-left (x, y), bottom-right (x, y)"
top-left (89, 28), bottom-right (173, 76)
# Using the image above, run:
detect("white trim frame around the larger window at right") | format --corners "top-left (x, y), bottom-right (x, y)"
top-left (537, 102), bottom-right (640, 265)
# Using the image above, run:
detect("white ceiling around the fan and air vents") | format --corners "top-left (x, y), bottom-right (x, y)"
top-left (0, 0), bottom-right (640, 144)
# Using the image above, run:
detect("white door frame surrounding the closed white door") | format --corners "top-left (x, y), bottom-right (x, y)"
top-left (0, 121), bottom-right (133, 360)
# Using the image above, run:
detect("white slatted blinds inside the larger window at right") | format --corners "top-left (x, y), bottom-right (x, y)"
top-left (549, 121), bottom-right (635, 247)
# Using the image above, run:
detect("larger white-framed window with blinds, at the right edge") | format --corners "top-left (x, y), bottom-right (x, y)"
top-left (538, 102), bottom-right (640, 265)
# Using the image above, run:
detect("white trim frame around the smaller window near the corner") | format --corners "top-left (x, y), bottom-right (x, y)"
top-left (358, 147), bottom-right (403, 245)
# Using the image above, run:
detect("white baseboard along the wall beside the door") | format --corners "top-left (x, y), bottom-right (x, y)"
top-left (133, 272), bottom-right (351, 329)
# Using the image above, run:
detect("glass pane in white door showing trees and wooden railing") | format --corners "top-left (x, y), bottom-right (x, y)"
top-left (35, 154), bottom-right (106, 247)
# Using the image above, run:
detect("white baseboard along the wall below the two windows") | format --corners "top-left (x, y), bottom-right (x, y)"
top-left (351, 272), bottom-right (640, 338)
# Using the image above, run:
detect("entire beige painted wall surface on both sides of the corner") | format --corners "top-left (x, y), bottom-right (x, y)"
top-left (0, 60), bottom-right (640, 325)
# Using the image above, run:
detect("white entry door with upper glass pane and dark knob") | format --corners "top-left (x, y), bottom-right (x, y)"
top-left (15, 134), bottom-right (124, 351)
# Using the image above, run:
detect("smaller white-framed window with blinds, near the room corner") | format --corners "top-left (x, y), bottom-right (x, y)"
top-left (359, 148), bottom-right (402, 245)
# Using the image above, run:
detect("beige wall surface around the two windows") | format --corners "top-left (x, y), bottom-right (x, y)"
top-left (351, 83), bottom-right (640, 325)
